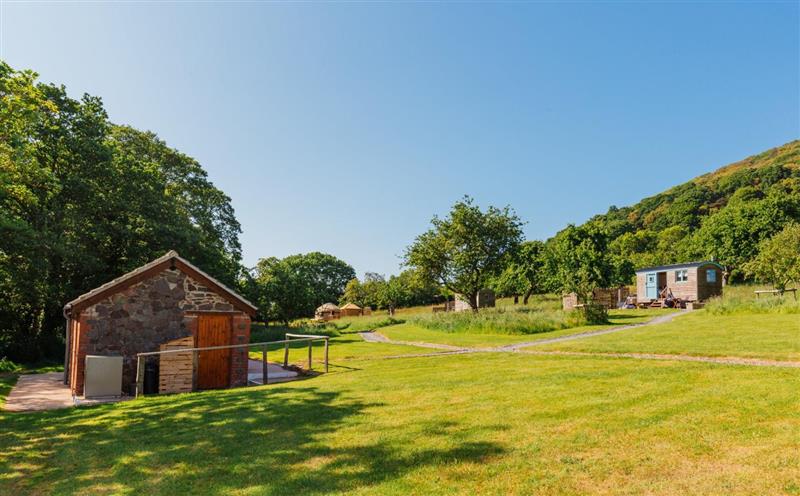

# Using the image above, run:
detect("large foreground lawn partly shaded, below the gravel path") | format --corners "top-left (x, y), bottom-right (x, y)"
top-left (0, 354), bottom-right (800, 495)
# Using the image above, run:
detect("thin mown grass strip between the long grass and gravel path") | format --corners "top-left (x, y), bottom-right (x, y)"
top-left (378, 309), bottom-right (675, 347)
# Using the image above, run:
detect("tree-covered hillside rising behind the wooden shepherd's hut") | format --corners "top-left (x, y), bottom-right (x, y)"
top-left (587, 141), bottom-right (800, 280)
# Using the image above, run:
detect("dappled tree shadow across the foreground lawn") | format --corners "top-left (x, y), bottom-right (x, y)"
top-left (0, 386), bottom-right (503, 494)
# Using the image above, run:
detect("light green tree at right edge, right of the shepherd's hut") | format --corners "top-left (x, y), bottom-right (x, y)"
top-left (745, 223), bottom-right (800, 291)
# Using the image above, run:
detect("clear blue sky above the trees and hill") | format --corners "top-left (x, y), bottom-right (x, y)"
top-left (0, 1), bottom-right (800, 274)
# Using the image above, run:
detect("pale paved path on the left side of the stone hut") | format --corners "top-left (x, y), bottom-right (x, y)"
top-left (4, 372), bottom-right (75, 412)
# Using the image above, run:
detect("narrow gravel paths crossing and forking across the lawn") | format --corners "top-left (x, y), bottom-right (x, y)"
top-left (358, 312), bottom-right (800, 368)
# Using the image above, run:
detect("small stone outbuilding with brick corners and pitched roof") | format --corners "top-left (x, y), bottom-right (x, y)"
top-left (64, 251), bottom-right (257, 396)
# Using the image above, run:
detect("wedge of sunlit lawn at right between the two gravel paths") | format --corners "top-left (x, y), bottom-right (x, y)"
top-left (531, 310), bottom-right (800, 360)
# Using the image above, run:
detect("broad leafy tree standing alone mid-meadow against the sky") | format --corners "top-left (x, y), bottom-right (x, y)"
top-left (404, 197), bottom-right (522, 311)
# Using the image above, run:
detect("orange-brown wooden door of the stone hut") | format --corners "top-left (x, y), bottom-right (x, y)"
top-left (197, 315), bottom-right (231, 389)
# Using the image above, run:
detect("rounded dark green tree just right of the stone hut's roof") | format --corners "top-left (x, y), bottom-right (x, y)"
top-left (251, 252), bottom-right (355, 324)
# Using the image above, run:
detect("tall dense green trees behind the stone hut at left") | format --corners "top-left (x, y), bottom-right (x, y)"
top-left (0, 62), bottom-right (241, 361)
